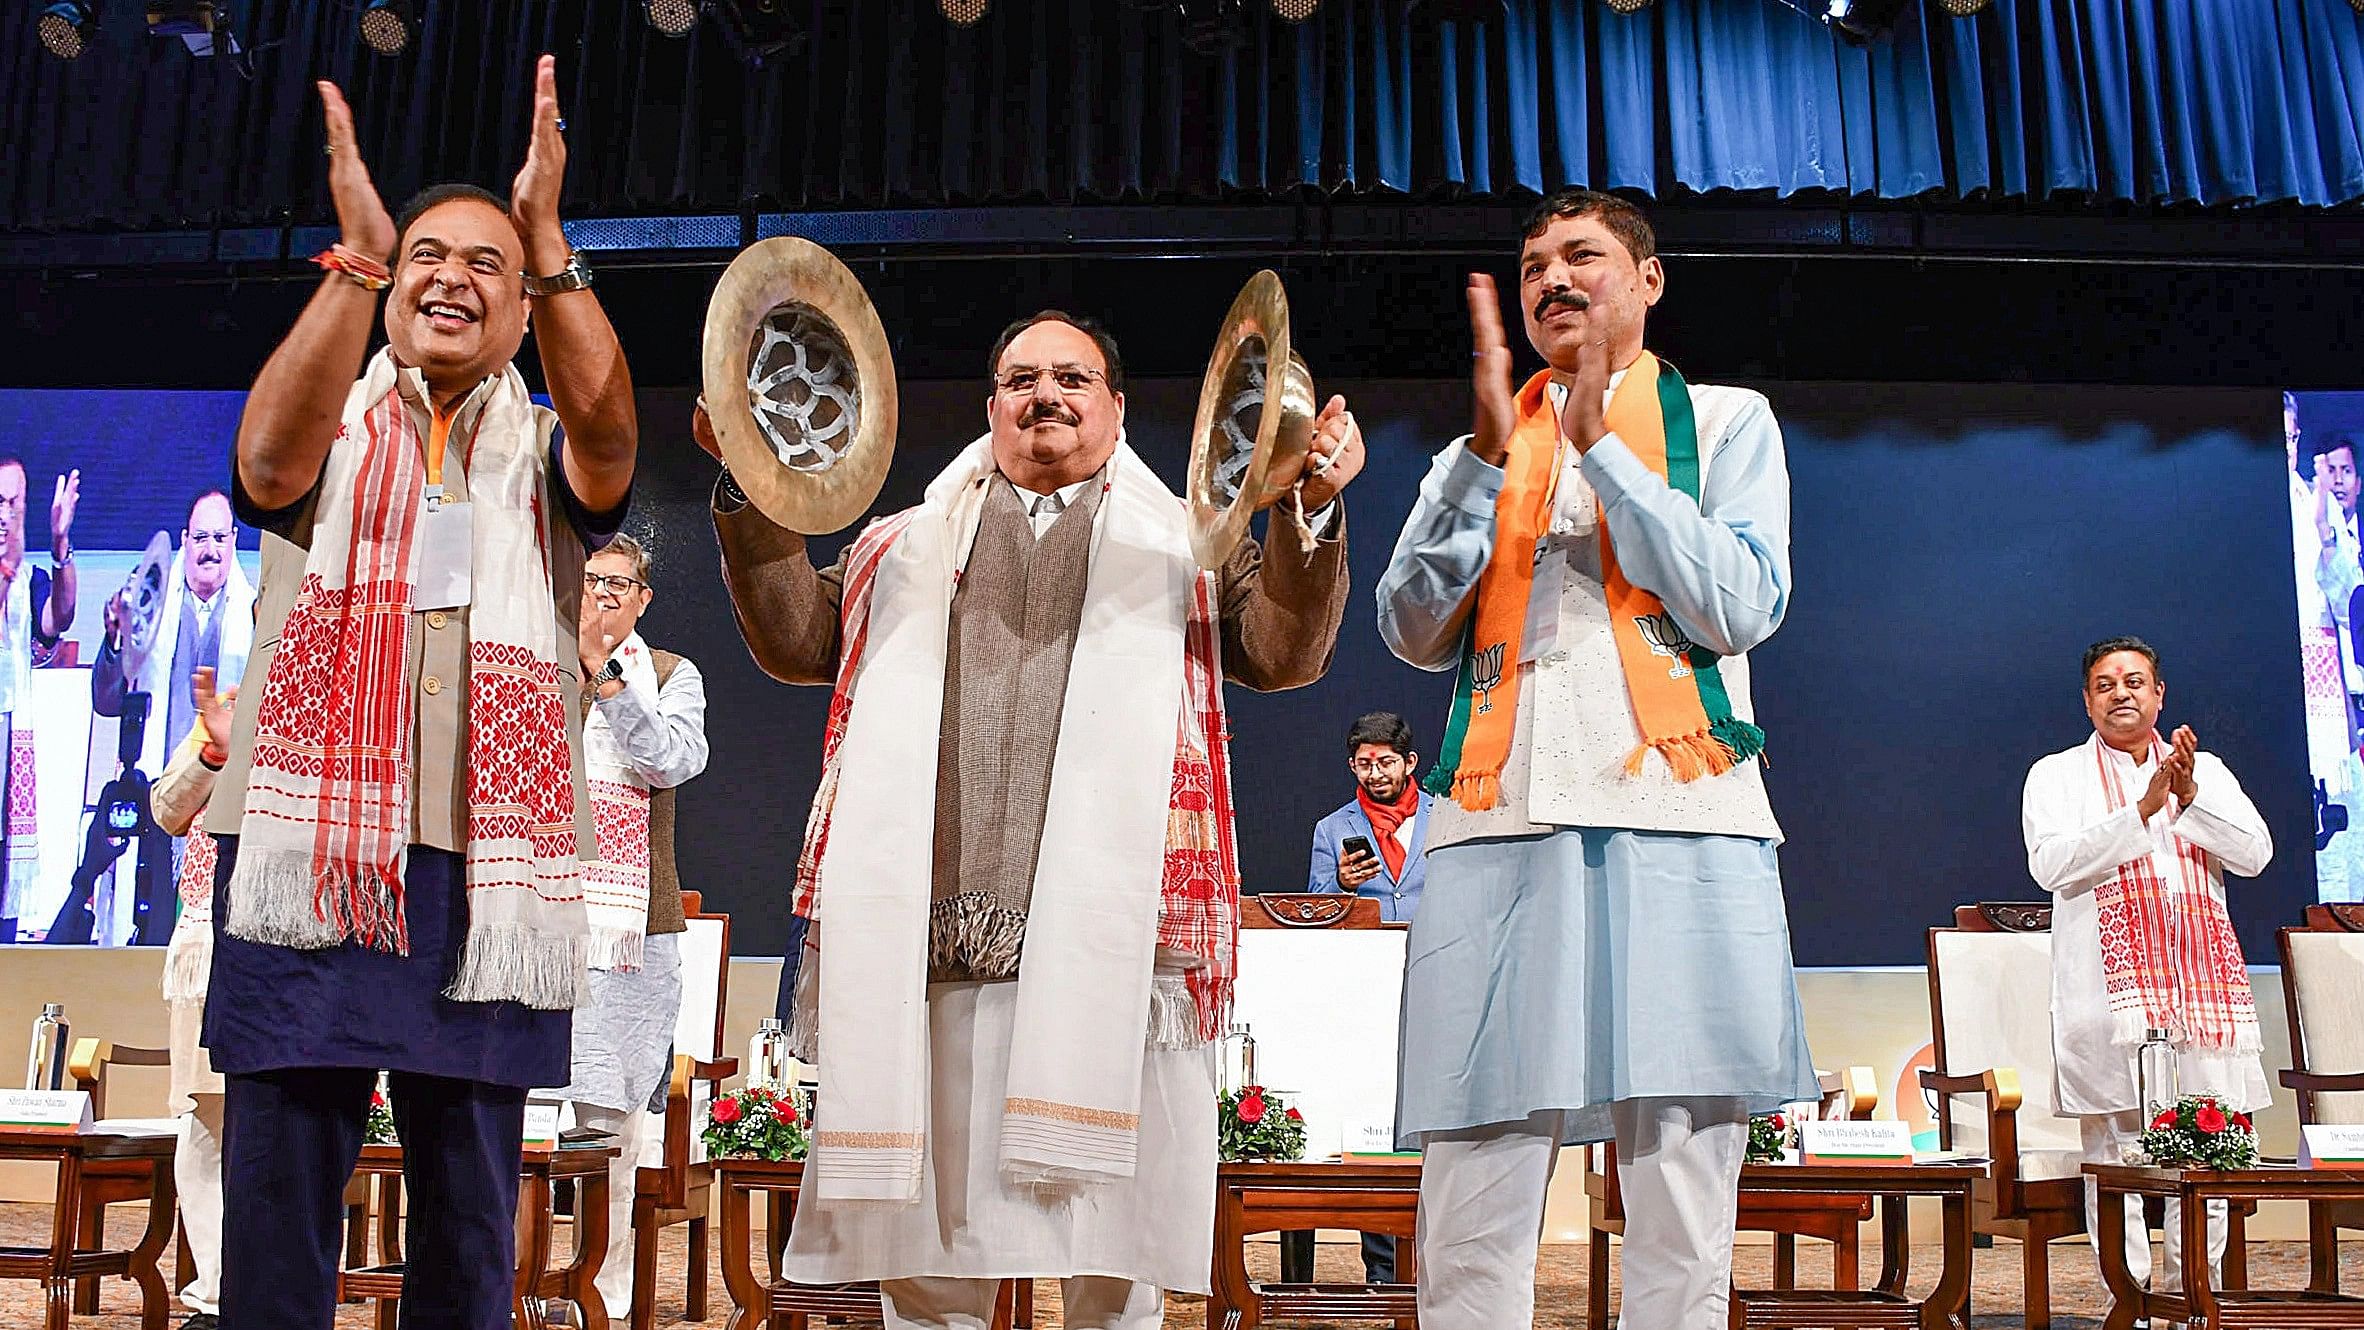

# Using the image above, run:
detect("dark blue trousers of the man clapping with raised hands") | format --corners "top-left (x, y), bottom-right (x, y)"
top-left (222, 1068), bottom-right (525, 1330)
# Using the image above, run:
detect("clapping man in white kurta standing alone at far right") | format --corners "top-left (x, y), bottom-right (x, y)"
top-left (2021, 638), bottom-right (2274, 1290)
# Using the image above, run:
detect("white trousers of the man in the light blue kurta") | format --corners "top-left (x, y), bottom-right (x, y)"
top-left (1418, 1098), bottom-right (1749, 1330)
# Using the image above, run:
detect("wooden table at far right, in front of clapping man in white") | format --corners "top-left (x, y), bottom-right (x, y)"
top-left (2085, 1165), bottom-right (2364, 1330)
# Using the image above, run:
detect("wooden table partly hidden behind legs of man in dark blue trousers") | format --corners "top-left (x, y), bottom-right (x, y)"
top-left (345, 1146), bottom-right (617, 1330)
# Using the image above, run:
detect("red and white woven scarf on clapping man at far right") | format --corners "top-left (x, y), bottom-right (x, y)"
top-left (2090, 735), bottom-right (2260, 1051)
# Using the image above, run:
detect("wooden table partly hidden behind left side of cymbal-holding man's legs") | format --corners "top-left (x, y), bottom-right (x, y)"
top-left (714, 1158), bottom-right (1033, 1330)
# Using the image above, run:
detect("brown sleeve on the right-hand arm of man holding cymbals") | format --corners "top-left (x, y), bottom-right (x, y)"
top-left (1222, 503), bottom-right (1347, 692)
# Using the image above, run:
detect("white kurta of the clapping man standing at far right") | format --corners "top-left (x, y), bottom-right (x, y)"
top-left (2021, 744), bottom-right (2274, 1115)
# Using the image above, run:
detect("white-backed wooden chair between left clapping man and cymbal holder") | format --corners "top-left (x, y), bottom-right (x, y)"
top-left (631, 891), bottom-right (738, 1330)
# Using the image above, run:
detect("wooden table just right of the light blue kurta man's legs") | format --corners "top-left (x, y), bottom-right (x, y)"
top-left (1730, 1162), bottom-right (1986, 1330)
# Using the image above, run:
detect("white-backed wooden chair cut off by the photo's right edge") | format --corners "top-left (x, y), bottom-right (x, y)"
top-left (2279, 905), bottom-right (2364, 1292)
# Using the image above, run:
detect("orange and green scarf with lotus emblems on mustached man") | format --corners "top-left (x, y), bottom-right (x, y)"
top-left (1428, 352), bottom-right (1766, 813)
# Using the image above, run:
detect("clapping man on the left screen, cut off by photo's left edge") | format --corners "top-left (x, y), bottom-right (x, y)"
top-left (0, 458), bottom-right (83, 943)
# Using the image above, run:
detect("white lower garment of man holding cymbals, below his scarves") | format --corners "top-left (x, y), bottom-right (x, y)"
top-left (780, 983), bottom-right (1215, 1304)
